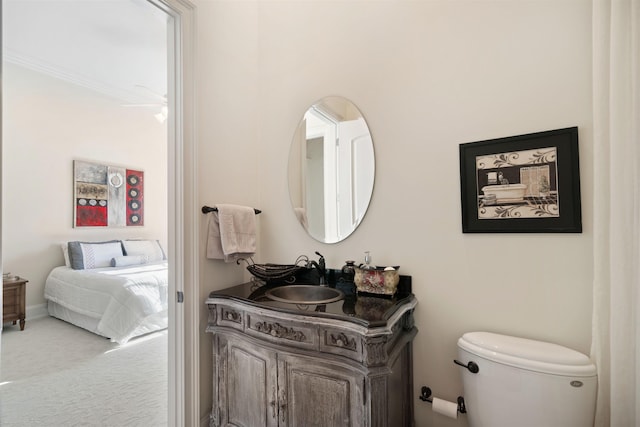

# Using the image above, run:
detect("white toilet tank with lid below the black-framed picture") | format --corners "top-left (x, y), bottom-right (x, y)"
top-left (455, 332), bottom-right (597, 427)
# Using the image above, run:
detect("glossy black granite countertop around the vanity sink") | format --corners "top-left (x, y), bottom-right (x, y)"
top-left (208, 275), bottom-right (415, 328)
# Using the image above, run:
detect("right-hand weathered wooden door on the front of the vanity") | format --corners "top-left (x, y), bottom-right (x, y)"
top-left (278, 353), bottom-right (366, 427)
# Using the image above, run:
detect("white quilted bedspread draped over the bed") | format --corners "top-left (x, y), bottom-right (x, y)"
top-left (44, 261), bottom-right (168, 344)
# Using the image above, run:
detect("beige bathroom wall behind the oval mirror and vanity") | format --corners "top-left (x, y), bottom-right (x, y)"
top-left (194, 0), bottom-right (593, 426)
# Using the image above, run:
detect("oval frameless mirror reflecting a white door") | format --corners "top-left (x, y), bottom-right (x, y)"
top-left (289, 96), bottom-right (375, 243)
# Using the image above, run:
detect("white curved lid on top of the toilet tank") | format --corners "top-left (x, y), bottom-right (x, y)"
top-left (458, 332), bottom-right (596, 376)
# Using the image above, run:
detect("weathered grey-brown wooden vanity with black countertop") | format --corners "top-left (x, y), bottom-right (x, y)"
top-left (207, 276), bottom-right (417, 427)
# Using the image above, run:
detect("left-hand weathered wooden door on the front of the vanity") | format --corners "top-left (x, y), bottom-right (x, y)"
top-left (213, 334), bottom-right (278, 427)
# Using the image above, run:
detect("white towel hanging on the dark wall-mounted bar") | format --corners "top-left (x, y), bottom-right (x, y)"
top-left (207, 205), bottom-right (256, 262)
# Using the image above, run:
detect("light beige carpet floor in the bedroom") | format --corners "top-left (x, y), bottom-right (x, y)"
top-left (0, 317), bottom-right (168, 427)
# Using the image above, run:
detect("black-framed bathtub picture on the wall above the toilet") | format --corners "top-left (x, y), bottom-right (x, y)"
top-left (460, 127), bottom-right (582, 233)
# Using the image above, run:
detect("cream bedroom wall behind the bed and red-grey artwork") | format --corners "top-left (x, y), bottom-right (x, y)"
top-left (2, 63), bottom-right (167, 310)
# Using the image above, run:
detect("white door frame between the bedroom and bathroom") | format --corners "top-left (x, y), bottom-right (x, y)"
top-left (147, 0), bottom-right (200, 427)
